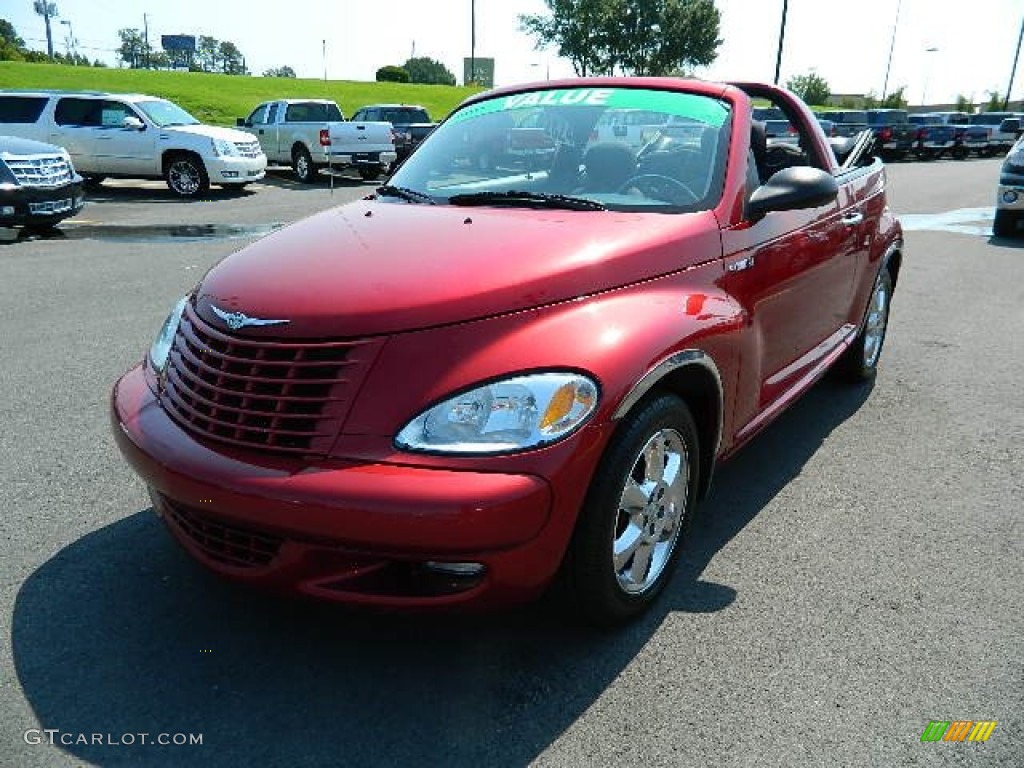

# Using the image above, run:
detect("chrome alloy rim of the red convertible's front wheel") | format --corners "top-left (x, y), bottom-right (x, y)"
top-left (612, 428), bottom-right (690, 595)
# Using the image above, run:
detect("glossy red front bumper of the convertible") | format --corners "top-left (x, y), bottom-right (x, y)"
top-left (112, 366), bottom-right (564, 607)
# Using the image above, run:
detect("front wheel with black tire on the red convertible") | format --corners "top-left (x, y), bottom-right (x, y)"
top-left (559, 394), bottom-right (700, 625)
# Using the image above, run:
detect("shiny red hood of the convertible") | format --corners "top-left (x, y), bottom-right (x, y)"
top-left (197, 200), bottom-right (721, 338)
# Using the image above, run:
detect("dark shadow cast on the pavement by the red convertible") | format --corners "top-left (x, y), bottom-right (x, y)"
top-left (11, 380), bottom-right (870, 768)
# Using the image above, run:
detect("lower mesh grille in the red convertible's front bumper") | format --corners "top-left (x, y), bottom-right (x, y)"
top-left (163, 498), bottom-right (285, 568)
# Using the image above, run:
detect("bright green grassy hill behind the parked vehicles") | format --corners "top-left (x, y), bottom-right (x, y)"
top-left (0, 61), bottom-right (480, 126)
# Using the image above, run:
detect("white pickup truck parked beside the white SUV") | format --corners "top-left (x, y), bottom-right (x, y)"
top-left (236, 98), bottom-right (398, 182)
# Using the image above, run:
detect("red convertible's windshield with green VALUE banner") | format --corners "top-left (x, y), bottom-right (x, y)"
top-left (385, 87), bottom-right (729, 213)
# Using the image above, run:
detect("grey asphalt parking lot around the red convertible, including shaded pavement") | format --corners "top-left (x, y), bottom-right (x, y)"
top-left (0, 159), bottom-right (1024, 768)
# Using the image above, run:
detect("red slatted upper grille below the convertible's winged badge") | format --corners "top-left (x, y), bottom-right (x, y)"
top-left (161, 305), bottom-right (382, 456)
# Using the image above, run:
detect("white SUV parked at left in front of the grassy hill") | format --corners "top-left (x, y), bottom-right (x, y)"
top-left (0, 91), bottom-right (266, 197)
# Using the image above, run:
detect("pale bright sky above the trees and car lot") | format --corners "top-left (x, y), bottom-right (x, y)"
top-left (8, 0), bottom-right (1024, 104)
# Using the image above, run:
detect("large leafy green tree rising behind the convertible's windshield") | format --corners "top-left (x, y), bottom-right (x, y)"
top-left (519, 0), bottom-right (722, 77)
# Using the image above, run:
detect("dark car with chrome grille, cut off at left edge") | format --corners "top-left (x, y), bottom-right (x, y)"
top-left (0, 136), bottom-right (85, 227)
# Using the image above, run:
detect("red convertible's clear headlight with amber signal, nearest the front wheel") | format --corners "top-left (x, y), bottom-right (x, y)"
top-left (395, 373), bottom-right (597, 454)
